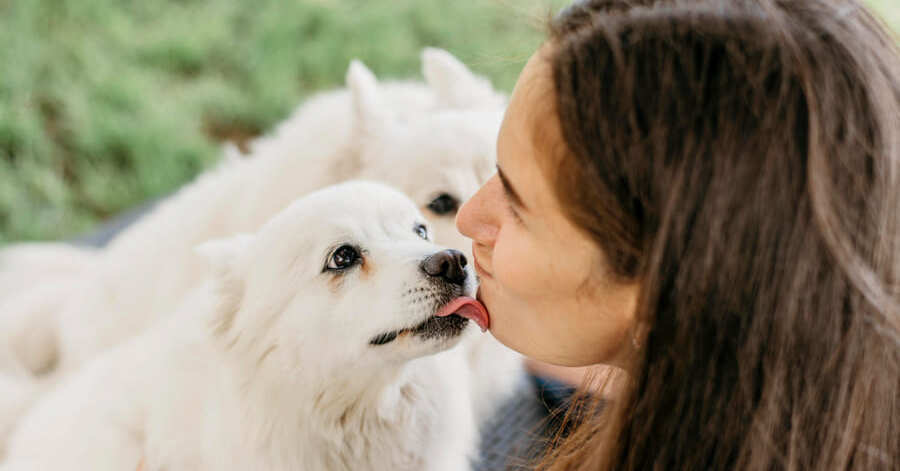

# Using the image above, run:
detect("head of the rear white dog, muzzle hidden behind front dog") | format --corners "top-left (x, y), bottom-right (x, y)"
top-left (347, 49), bottom-right (506, 253)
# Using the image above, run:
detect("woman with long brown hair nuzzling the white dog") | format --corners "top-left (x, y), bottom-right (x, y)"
top-left (457, 0), bottom-right (900, 470)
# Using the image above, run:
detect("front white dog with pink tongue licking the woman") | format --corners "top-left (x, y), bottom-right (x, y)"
top-left (2, 182), bottom-right (486, 471)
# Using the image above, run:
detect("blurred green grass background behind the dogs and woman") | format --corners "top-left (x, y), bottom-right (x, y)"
top-left (0, 0), bottom-right (900, 245)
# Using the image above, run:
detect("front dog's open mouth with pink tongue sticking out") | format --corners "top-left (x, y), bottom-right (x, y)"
top-left (369, 296), bottom-right (488, 345)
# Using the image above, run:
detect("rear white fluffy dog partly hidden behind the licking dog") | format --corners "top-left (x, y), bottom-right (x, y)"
top-left (0, 49), bottom-right (520, 456)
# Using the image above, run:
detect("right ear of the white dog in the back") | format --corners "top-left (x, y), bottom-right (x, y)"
top-left (422, 47), bottom-right (505, 109)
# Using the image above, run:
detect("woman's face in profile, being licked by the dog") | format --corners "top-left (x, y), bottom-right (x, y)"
top-left (456, 47), bottom-right (638, 372)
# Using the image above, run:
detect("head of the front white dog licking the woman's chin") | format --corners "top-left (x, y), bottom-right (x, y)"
top-left (199, 182), bottom-right (481, 374)
